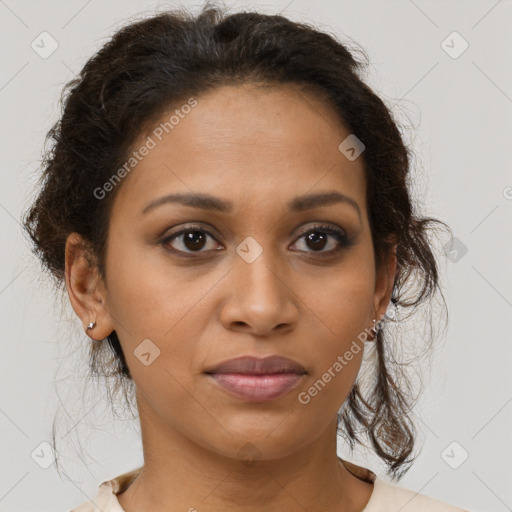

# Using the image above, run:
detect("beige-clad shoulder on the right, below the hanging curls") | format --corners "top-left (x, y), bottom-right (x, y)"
top-left (363, 478), bottom-right (469, 512)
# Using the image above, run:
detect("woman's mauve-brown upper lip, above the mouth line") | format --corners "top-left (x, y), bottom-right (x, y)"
top-left (205, 355), bottom-right (306, 375)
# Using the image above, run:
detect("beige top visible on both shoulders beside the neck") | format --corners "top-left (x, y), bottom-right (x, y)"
top-left (69, 459), bottom-right (469, 512)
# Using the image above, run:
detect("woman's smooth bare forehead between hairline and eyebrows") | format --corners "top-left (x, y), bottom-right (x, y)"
top-left (112, 84), bottom-right (365, 218)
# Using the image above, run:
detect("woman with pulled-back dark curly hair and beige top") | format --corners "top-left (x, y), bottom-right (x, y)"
top-left (24, 5), bottom-right (472, 512)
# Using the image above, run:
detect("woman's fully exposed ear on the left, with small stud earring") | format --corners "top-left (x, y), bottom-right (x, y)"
top-left (65, 233), bottom-right (114, 340)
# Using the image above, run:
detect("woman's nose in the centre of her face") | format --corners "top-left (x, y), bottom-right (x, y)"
top-left (220, 251), bottom-right (299, 336)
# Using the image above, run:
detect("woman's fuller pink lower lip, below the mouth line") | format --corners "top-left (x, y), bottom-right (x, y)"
top-left (210, 373), bottom-right (304, 402)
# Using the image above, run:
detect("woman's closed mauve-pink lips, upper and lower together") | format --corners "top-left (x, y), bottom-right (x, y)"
top-left (204, 355), bottom-right (307, 402)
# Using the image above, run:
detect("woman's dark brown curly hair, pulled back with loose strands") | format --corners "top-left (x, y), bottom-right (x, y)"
top-left (23, 2), bottom-right (450, 479)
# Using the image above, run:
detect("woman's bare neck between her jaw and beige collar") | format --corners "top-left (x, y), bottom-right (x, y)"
top-left (118, 424), bottom-right (373, 512)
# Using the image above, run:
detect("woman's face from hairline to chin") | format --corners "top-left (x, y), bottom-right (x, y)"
top-left (80, 85), bottom-right (395, 459)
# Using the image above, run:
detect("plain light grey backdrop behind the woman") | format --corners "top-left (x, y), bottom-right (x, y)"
top-left (0, 0), bottom-right (512, 512)
